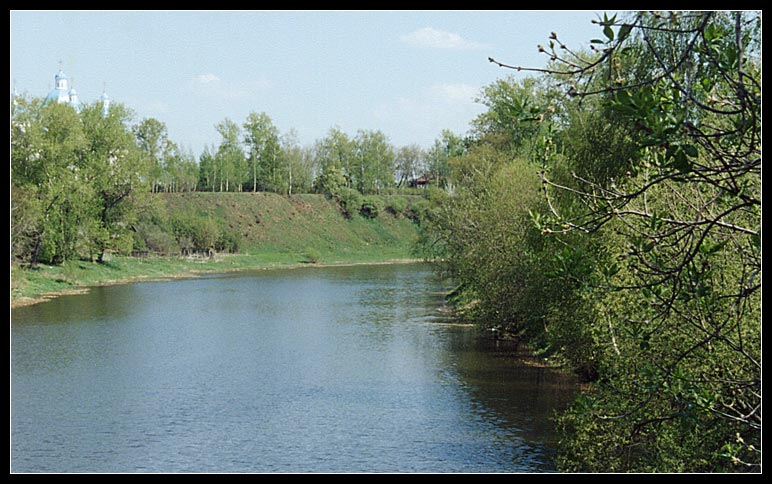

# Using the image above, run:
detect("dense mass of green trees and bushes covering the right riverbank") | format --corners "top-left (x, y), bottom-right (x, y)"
top-left (422, 11), bottom-right (761, 472)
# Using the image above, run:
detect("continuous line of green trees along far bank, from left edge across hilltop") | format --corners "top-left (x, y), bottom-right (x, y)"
top-left (11, 96), bottom-right (461, 266)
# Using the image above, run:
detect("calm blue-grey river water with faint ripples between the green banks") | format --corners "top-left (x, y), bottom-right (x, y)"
top-left (11, 264), bottom-right (575, 473)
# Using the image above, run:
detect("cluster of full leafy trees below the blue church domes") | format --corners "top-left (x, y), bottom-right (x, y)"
top-left (11, 99), bottom-right (146, 265)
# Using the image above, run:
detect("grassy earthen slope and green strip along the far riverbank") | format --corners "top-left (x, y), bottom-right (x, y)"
top-left (11, 193), bottom-right (426, 306)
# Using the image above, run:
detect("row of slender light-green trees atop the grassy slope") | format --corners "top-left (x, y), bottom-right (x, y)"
top-left (197, 112), bottom-right (462, 195)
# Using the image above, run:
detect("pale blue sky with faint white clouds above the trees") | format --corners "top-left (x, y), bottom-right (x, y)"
top-left (10, 10), bottom-right (614, 156)
